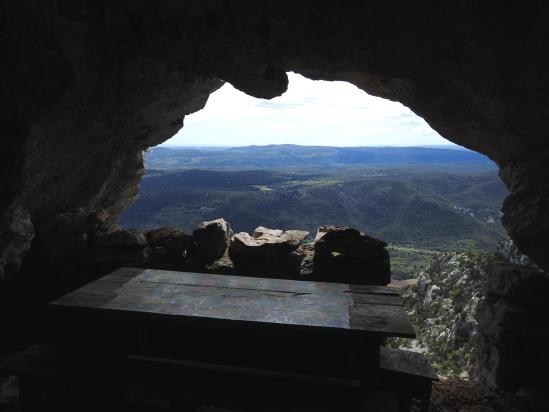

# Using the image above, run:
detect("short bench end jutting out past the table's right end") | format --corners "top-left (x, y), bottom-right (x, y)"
top-left (379, 347), bottom-right (437, 412)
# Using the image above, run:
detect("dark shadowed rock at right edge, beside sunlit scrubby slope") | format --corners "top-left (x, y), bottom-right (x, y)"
top-left (472, 261), bottom-right (549, 393)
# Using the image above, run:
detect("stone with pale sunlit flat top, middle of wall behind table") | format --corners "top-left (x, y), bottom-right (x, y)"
top-left (229, 226), bottom-right (309, 278)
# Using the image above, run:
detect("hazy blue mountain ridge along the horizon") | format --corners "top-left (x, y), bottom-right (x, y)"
top-left (145, 145), bottom-right (496, 171)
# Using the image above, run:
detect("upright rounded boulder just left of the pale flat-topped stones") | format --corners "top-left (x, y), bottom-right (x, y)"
top-left (193, 219), bottom-right (232, 264)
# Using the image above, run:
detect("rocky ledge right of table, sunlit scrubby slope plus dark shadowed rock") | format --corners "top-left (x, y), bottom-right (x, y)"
top-left (391, 241), bottom-right (549, 410)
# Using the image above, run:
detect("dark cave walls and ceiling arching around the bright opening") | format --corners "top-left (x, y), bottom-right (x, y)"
top-left (0, 0), bottom-right (549, 408)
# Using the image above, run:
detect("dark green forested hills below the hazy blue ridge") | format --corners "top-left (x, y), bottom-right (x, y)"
top-left (120, 168), bottom-right (506, 250)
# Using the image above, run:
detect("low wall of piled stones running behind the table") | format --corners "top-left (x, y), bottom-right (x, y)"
top-left (20, 217), bottom-right (390, 289)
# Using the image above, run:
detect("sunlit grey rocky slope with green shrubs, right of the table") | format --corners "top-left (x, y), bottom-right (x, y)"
top-left (398, 253), bottom-right (492, 376)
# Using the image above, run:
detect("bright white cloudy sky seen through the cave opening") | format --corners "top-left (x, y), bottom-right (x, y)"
top-left (163, 73), bottom-right (451, 146)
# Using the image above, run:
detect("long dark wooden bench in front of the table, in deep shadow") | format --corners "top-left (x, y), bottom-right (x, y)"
top-left (0, 345), bottom-right (360, 412)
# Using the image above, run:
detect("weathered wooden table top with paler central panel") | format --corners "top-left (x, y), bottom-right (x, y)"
top-left (51, 268), bottom-right (415, 337)
